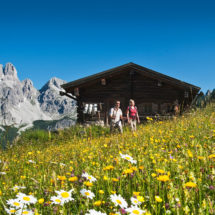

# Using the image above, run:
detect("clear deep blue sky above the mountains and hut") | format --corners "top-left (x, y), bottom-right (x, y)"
top-left (0, 0), bottom-right (215, 91)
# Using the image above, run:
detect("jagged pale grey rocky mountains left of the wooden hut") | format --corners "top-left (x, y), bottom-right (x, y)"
top-left (0, 63), bottom-right (76, 129)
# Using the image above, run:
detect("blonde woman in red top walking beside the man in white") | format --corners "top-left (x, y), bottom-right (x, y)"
top-left (127, 99), bottom-right (140, 131)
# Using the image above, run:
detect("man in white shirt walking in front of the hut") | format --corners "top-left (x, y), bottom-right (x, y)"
top-left (109, 101), bottom-right (123, 134)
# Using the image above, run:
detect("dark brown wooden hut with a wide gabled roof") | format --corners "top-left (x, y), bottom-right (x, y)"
top-left (61, 63), bottom-right (200, 124)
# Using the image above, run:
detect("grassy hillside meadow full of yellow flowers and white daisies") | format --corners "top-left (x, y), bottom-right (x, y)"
top-left (0, 104), bottom-right (215, 215)
